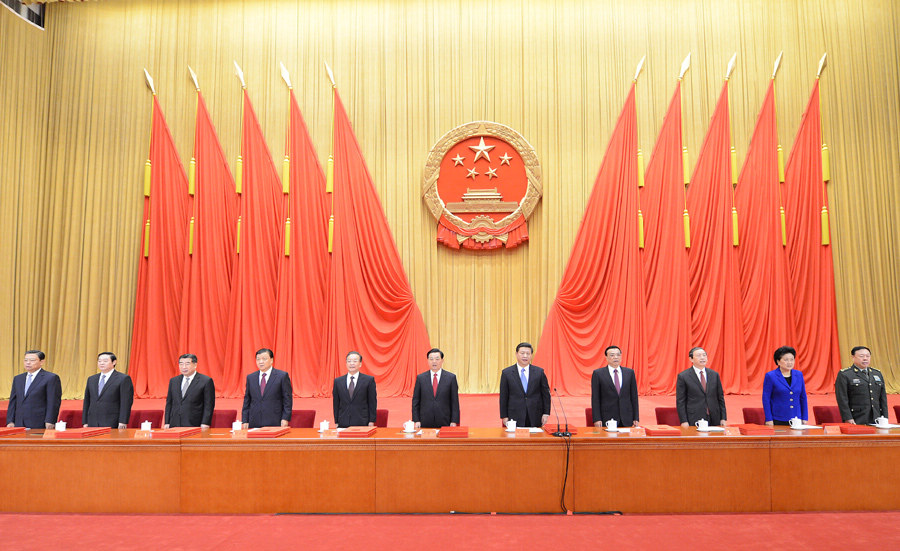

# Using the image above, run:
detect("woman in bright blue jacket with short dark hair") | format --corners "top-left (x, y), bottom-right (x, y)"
top-left (763, 346), bottom-right (809, 425)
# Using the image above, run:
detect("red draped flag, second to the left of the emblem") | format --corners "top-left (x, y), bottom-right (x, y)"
top-left (275, 90), bottom-right (331, 396)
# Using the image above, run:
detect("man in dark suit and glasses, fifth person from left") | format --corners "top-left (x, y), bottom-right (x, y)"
top-left (331, 352), bottom-right (378, 427)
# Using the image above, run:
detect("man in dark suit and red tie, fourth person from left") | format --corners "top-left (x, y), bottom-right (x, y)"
top-left (241, 348), bottom-right (294, 429)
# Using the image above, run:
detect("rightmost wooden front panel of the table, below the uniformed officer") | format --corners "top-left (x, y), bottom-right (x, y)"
top-left (771, 435), bottom-right (900, 511)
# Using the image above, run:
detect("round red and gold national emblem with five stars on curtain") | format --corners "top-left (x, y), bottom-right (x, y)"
top-left (423, 121), bottom-right (541, 249)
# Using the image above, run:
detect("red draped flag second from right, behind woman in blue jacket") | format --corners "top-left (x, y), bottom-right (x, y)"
top-left (734, 80), bottom-right (794, 391)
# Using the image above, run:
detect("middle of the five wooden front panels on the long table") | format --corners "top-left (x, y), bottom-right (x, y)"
top-left (375, 428), bottom-right (572, 513)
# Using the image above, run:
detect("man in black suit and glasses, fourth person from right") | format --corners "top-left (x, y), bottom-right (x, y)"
top-left (591, 346), bottom-right (639, 427)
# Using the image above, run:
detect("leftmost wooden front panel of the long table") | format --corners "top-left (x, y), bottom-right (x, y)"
top-left (0, 430), bottom-right (181, 513)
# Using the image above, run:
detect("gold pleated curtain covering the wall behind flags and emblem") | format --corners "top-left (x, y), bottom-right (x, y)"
top-left (0, 0), bottom-right (900, 398)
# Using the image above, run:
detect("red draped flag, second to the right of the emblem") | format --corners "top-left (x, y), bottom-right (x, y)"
top-left (641, 82), bottom-right (692, 394)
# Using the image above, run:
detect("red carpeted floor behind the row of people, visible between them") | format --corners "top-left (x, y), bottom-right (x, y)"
top-left (26, 394), bottom-right (900, 427)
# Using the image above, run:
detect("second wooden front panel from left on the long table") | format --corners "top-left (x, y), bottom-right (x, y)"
top-left (181, 429), bottom-right (375, 514)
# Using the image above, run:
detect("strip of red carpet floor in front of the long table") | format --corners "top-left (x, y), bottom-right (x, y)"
top-left (0, 512), bottom-right (900, 551)
